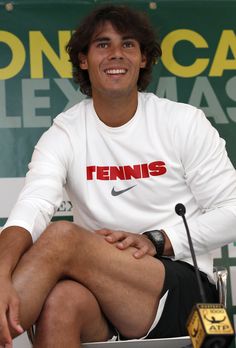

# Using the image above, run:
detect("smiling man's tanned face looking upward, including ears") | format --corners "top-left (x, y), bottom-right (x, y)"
top-left (79, 22), bottom-right (146, 98)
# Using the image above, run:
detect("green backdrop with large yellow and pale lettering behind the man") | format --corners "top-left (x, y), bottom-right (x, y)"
top-left (0, 0), bottom-right (236, 346)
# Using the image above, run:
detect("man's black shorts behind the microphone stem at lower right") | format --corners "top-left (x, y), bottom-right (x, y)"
top-left (145, 258), bottom-right (219, 339)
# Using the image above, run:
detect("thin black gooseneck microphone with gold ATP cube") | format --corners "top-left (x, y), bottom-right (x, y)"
top-left (175, 203), bottom-right (234, 348)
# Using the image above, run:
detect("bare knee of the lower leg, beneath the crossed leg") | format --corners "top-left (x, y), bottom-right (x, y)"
top-left (34, 280), bottom-right (112, 348)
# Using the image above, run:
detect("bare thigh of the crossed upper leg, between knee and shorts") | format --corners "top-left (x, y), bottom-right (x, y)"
top-left (61, 226), bottom-right (165, 338)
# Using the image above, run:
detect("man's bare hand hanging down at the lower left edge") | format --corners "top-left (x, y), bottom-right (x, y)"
top-left (0, 276), bottom-right (24, 348)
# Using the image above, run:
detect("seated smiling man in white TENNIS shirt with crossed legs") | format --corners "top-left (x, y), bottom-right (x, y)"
top-left (0, 6), bottom-right (236, 348)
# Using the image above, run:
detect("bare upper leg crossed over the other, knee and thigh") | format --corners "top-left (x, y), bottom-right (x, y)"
top-left (13, 222), bottom-right (164, 338)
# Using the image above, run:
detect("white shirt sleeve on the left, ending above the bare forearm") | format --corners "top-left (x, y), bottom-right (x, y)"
top-left (4, 119), bottom-right (73, 241)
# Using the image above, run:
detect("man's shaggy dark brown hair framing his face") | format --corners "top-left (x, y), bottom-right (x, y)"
top-left (66, 5), bottom-right (162, 97)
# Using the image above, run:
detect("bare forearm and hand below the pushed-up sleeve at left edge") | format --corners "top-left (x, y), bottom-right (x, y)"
top-left (0, 226), bottom-right (32, 345)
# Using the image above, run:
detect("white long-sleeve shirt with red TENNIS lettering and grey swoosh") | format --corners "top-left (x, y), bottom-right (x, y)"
top-left (5, 93), bottom-right (236, 275)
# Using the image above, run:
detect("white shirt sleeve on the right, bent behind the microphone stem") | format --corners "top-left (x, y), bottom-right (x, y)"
top-left (164, 109), bottom-right (236, 259)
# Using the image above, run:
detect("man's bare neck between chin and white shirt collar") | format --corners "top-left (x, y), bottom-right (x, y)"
top-left (93, 92), bottom-right (138, 127)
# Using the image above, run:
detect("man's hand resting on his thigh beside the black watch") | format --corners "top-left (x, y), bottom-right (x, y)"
top-left (96, 229), bottom-right (156, 259)
